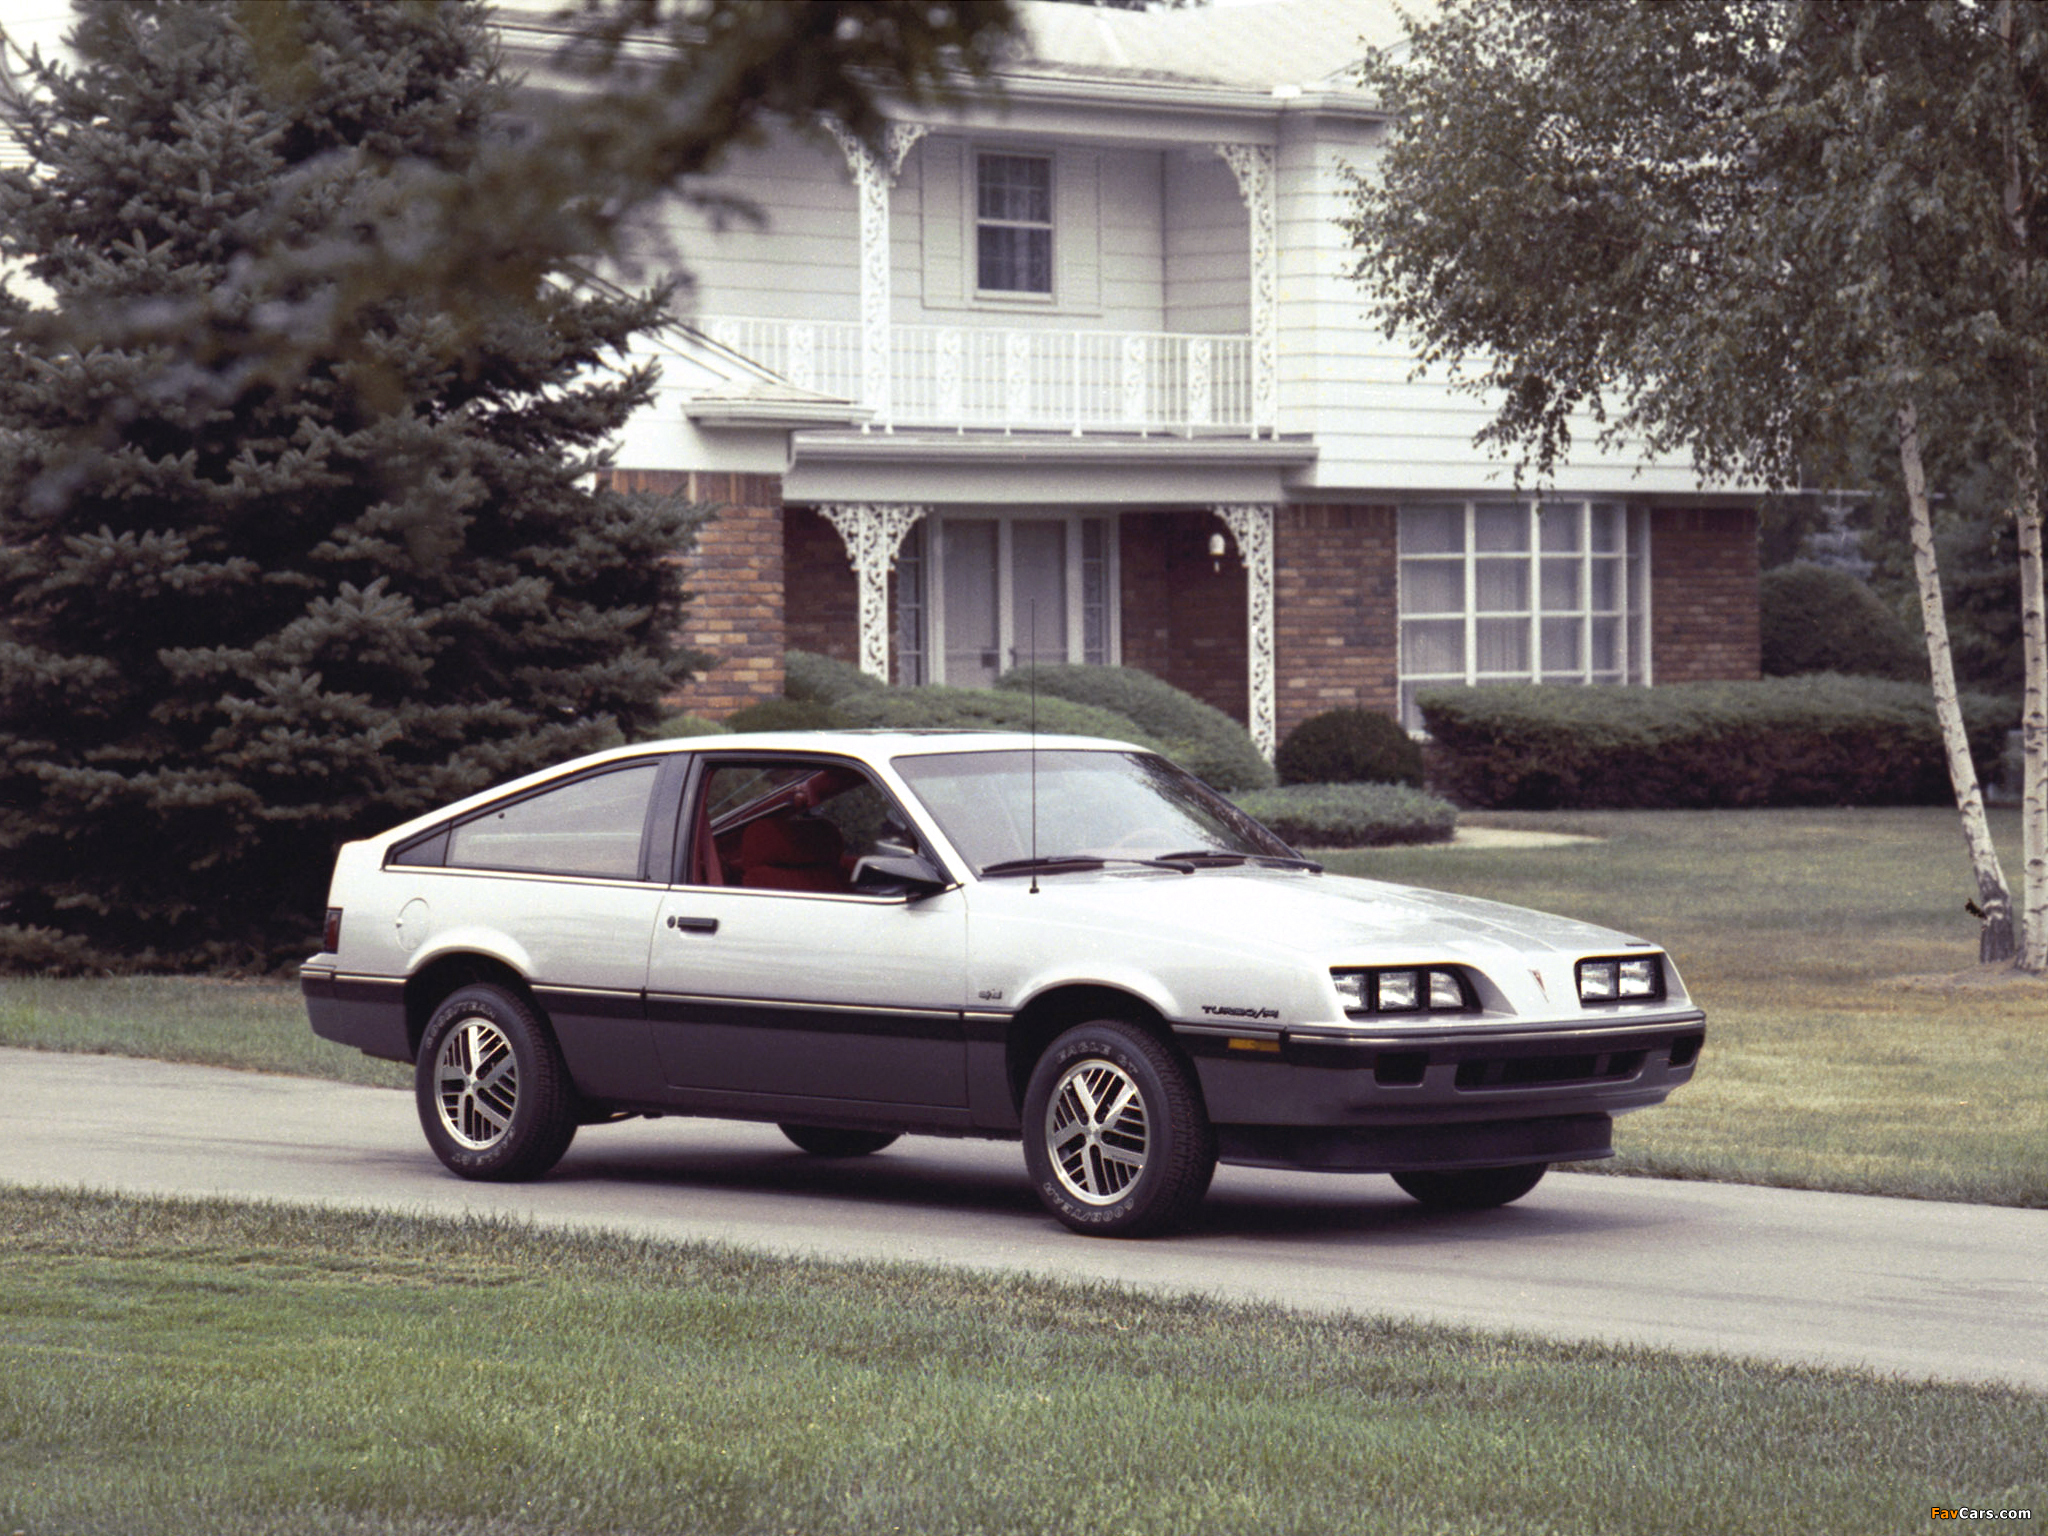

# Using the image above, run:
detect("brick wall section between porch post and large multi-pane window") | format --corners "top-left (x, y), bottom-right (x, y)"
top-left (1274, 506), bottom-right (1401, 741)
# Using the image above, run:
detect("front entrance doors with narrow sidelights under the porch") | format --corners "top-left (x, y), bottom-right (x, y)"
top-left (891, 512), bottom-right (1120, 688)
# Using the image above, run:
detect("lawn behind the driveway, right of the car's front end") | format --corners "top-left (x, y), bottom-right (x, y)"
top-left (1329, 807), bottom-right (2048, 1206)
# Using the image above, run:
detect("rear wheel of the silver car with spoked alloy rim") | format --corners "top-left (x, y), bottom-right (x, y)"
top-left (414, 983), bottom-right (578, 1182)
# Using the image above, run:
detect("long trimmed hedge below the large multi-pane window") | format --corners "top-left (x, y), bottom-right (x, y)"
top-left (1419, 674), bottom-right (2015, 809)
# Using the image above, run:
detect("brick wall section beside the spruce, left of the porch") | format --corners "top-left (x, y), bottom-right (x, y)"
top-left (610, 469), bottom-right (786, 719)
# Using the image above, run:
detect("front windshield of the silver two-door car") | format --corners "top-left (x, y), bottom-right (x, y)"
top-left (895, 750), bottom-right (1292, 874)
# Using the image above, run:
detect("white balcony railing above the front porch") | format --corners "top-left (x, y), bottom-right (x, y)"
top-left (696, 315), bottom-right (1251, 434)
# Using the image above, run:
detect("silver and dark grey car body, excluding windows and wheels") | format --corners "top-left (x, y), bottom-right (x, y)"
top-left (301, 733), bottom-right (1704, 1171)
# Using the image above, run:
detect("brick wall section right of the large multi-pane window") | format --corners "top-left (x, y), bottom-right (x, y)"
top-left (1651, 508), bottom-right (1761, 682)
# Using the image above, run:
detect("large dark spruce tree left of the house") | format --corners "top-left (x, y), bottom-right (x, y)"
top-left (0, 0), bottom-right (698, 969)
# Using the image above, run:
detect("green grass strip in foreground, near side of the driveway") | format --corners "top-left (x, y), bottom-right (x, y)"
top-left (0, 1190), bottom-right (2048, 1536)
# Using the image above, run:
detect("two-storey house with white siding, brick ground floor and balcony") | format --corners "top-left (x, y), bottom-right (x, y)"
top-left (483, 0), bottom-right (1757, 750)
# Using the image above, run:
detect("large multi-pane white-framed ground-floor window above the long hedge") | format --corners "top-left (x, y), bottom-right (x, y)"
top-left (1401, 498), bottom-right (1651, 731)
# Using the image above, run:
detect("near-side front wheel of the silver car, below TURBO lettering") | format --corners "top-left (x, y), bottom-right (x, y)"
top-left (1024, 1020), bottom-right (1217, 1237)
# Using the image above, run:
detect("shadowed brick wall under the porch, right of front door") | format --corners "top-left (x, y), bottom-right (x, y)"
top-left (1116, 512), bottom-right (1249, 721)
